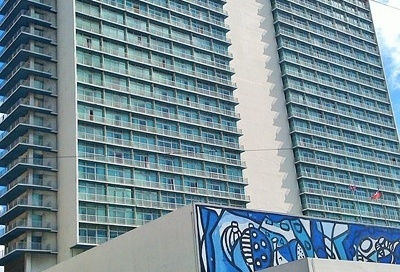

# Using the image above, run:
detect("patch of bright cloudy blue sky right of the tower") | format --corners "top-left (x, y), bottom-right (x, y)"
top-left (370, 0), bottom-right (400, 132)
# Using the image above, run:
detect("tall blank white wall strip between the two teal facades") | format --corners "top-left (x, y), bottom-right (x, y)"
top-left (225, 0), bottom-right (301, 215)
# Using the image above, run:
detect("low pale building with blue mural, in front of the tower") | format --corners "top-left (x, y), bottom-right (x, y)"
top-left (46, 204), bottom-right (400, 272)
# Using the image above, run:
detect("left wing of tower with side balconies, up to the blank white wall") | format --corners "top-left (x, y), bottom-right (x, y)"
top-left (0, 0), bottom-right (249, 271)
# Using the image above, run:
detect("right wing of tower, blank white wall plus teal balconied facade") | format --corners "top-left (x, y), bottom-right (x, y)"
top-left (226, 0), bottom-right (400, 227)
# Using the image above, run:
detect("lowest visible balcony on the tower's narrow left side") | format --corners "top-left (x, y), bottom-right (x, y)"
top-left (0, 241), bottom-right (57, 265)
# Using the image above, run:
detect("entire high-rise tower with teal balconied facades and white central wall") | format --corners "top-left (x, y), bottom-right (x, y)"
top-left (0, 0), bottom-right (400, 272)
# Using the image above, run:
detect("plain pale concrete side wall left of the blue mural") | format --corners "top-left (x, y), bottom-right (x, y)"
top-left (45, 205), bottom-right (199, 272)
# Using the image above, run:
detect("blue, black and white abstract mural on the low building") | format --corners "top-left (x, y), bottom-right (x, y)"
top-left (196, 205), bottom-right (400, 272)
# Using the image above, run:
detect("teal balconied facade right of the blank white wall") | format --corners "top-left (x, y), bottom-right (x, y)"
top-left (271, 0), bottom-right (400, 227)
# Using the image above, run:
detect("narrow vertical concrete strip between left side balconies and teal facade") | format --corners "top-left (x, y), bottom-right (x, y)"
top-left (57, 0), bottom-right (78, 262)
